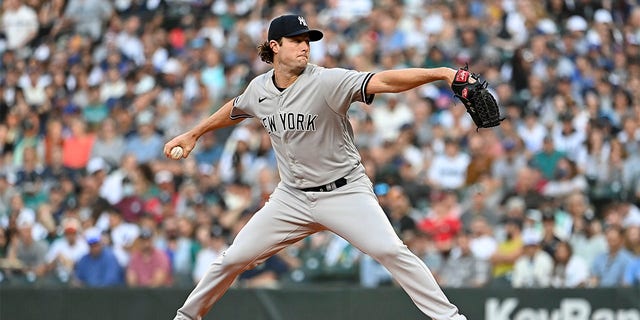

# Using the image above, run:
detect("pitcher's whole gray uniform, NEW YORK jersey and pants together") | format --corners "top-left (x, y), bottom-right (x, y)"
top-left (174, 64), bottom-right (466, 320)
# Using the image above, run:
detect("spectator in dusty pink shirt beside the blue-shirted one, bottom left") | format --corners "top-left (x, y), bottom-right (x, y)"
top-left (126, 229), bottom-right (173, 288)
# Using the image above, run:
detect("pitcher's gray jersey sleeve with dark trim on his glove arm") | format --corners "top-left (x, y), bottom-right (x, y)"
top-left (323, 68), bottom-right (375, 112)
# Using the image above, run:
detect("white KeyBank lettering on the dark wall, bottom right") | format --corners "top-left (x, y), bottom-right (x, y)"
top-left (484, 298), bottom-right (640, 320)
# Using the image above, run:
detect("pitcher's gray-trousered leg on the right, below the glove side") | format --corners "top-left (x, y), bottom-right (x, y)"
top-left (312, 177), bottom-right (466, 320)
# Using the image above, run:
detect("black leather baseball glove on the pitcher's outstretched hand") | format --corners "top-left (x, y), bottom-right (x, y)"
top-left (451, 64), bottom-right (504, 130)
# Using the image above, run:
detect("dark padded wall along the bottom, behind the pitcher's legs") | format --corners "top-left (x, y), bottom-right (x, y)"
top-left (0, 287), bottom-right (640, 320)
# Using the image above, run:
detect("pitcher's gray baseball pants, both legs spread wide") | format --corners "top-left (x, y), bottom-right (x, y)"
top-left (174, 167), bottom-right (466, 320)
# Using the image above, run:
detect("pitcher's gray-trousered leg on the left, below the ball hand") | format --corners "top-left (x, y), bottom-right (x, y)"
top-left (175, 188), bottom-right (318, 320)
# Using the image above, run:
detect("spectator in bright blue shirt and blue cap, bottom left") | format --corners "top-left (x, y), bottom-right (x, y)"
top-left (74, 230), bottom-right (124, 287)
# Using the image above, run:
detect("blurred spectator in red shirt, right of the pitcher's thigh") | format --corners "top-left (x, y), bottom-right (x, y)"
top-left (418, 190), bottom-right (462, 252)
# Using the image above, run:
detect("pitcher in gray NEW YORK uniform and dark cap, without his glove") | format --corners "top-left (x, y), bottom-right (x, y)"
top-left (164, 15), bottom-right (466, 320)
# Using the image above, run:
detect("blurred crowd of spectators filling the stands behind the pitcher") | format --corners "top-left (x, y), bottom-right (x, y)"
top-left (0, 0), bottom-right (640, 288)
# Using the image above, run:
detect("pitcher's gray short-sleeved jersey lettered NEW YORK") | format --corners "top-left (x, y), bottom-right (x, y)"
top-left (231, 64), bottom-right (373, 189)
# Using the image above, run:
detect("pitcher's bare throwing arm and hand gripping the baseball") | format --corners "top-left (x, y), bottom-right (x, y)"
top-left (164, 100), bottom-right (244, 158)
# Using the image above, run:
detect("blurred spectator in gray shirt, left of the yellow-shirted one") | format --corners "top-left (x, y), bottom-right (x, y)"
top-left (438, 232), bottom-right (491, 288)
